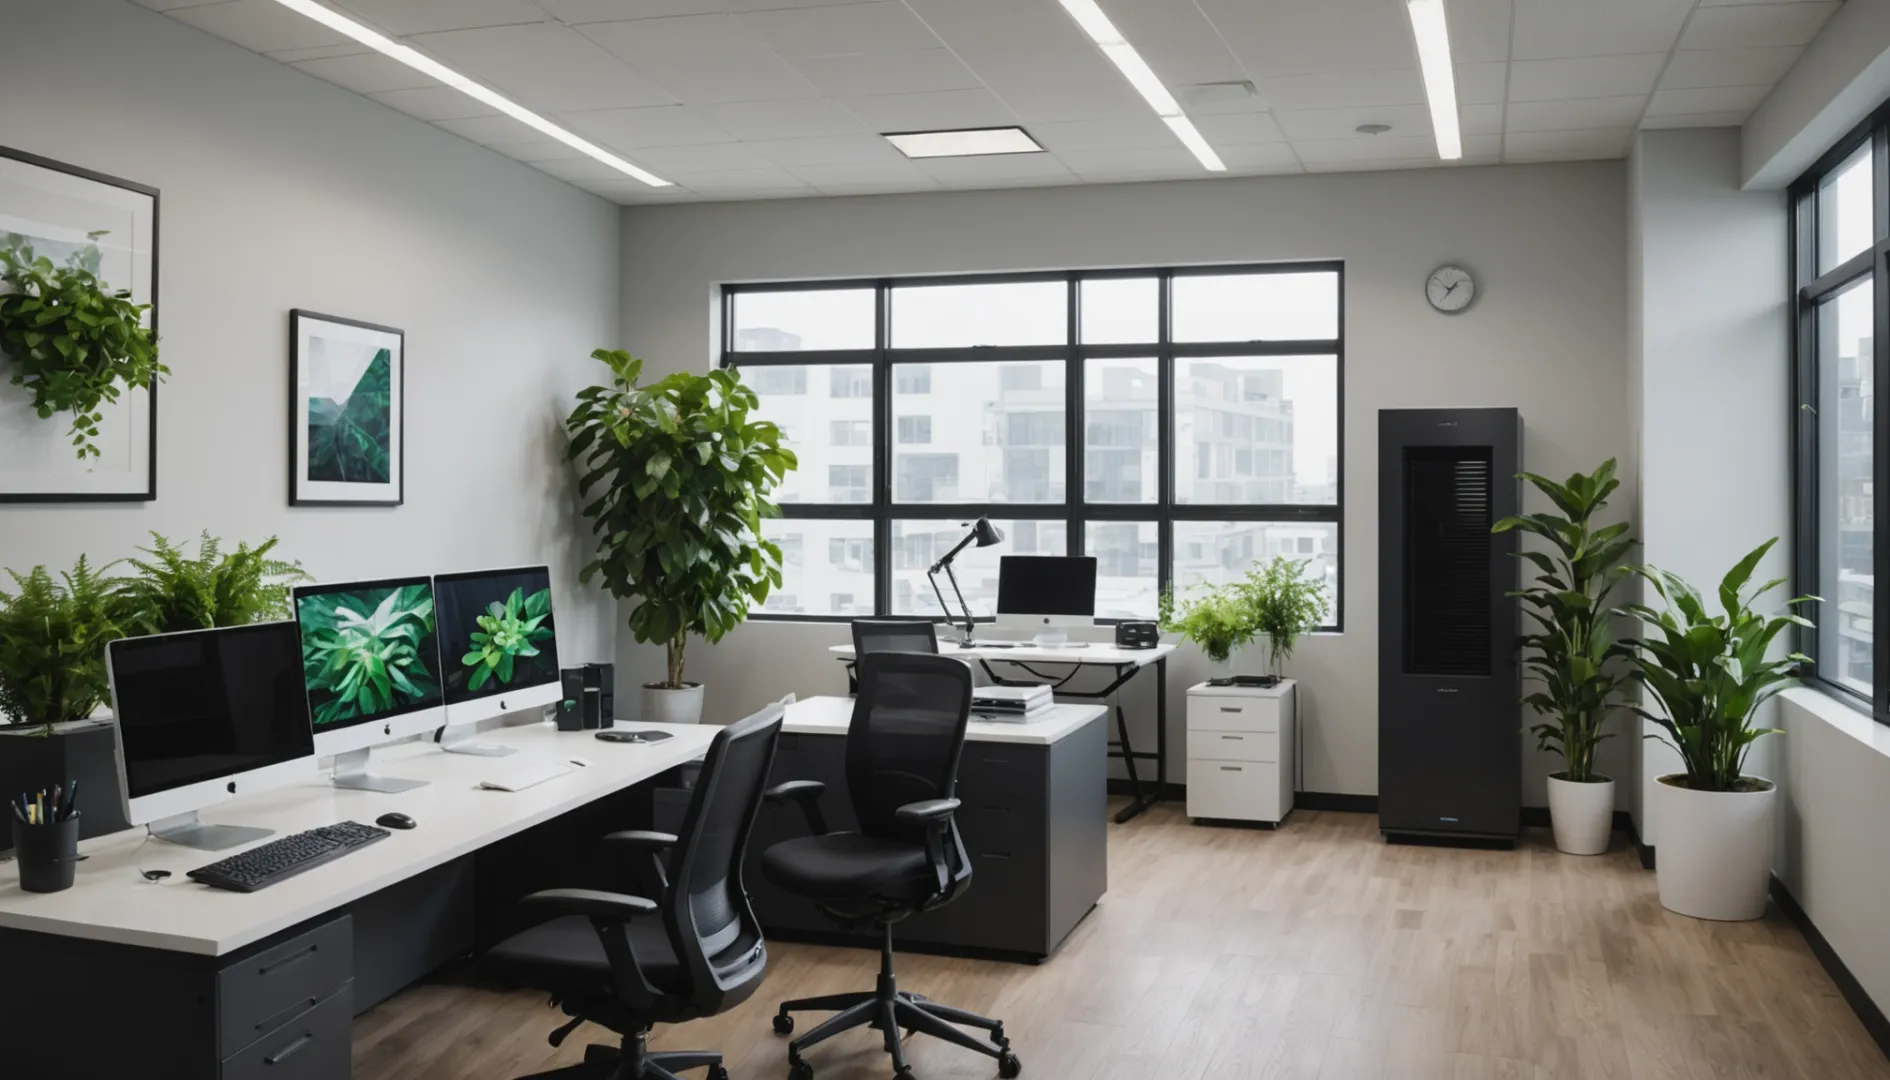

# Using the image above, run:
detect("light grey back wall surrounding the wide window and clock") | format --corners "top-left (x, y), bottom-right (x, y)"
top-left (620, 163), bottom-right (1633, 804)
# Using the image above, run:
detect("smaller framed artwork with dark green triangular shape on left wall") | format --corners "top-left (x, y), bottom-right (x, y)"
top-left (289, 308), bottom-right (406, 507)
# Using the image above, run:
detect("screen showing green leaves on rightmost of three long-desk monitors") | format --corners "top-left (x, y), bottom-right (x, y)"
top-left (433, 566), bottom-right (558, 705)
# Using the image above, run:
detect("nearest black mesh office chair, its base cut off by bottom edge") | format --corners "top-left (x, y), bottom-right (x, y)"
top-left (486, 704), bottom-right (782, 1080)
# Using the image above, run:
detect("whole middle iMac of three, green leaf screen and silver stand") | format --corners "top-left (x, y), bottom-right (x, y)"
top-left (295, 577), bottom-right (446, 793)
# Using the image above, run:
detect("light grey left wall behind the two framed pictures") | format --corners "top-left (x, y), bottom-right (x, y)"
top-left (0, 0), bottom-right (618, 658)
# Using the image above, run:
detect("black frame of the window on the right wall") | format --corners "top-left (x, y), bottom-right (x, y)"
top-left (1788, 102), bottom-right (1890, 724)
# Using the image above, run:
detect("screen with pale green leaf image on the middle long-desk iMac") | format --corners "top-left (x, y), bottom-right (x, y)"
top-left (297, 584), bottom-right (438, 728)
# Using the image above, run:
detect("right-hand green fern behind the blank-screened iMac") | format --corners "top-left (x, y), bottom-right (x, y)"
top-left (123, 531), bottom-right (312, 634)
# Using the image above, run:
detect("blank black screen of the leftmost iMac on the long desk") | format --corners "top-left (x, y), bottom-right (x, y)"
top-left (106, 622), bottom-right (316, 798)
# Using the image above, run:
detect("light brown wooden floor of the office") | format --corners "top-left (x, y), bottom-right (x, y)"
top-left (355, 808), bottom-right (1890, 1080)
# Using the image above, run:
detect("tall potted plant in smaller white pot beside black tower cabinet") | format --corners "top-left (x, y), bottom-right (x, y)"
top-left (1491, 458), bottom-right (1635, 855)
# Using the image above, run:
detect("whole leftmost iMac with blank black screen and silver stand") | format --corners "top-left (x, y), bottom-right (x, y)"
top-left (106, 622), bottom-right (316, 851)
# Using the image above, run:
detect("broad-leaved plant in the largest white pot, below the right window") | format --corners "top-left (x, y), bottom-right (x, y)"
top-left (1622, 537), bottom-right (1816, 919)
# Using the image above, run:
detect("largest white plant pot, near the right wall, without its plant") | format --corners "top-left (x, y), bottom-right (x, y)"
top-left (1654, 775), bottom-right (1778, 921)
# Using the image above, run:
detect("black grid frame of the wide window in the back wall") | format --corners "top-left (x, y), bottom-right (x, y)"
top-left (718, 259), bottom-right (1346, 634)
